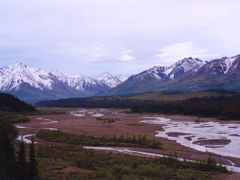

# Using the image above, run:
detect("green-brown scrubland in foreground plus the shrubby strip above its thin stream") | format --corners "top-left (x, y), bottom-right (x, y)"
top-left (34, 130), bottom-right (227, 180)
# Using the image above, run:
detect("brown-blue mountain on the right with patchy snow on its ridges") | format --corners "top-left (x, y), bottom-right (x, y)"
top-left (105, 55), bottom-right (240, 95)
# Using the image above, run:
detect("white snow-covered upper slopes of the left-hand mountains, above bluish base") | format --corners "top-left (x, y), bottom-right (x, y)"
top-left (0, 63), bottom-right (108, 91)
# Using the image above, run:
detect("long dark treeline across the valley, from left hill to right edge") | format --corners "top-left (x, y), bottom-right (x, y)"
top-left (37, 91), bottom-right (240, 120)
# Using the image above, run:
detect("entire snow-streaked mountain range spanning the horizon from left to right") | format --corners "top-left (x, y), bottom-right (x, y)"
top-left (0, 55), bottom-right (240, 103)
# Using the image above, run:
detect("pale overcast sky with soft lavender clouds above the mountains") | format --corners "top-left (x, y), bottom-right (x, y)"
top-left (0, 0), bottom-right (240, 76)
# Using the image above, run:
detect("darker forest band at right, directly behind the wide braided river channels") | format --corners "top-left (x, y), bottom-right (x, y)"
top-left (131, 95), bottom-right (240, 120)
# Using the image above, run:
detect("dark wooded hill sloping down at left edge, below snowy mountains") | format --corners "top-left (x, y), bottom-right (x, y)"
top-left (0, 93), bottom-right (35, 112)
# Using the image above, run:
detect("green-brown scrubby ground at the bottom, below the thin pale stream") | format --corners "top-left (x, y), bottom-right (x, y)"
top-left (37, 145), bottom-right (227, 180)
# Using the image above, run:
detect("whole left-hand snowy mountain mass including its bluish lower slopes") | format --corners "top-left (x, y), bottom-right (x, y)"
top-left (0, 63), bottom-right (110, 102)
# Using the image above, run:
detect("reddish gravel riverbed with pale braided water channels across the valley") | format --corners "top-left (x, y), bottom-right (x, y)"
top-left (16, 109), bottom-right (240, 179)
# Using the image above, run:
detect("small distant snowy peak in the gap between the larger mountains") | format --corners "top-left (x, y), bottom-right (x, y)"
top-left (97, 72), bottom-right (122, 88)
